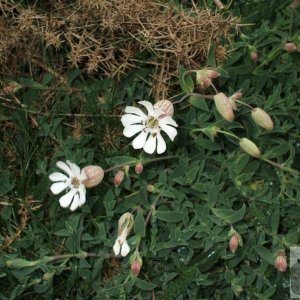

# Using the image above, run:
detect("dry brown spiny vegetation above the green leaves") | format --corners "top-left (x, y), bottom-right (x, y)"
top-left (0, 0), bottom-right (236, 98)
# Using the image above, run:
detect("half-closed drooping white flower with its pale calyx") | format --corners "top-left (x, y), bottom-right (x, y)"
top-left (113, 213), bottom-right (134, 257)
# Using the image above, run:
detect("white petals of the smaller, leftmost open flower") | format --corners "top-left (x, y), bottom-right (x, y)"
top-left (49, 160), bottom-right (87, 211)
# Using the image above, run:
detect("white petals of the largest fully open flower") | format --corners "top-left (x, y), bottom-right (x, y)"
top-left (121, 101), bottom-right (178, 154)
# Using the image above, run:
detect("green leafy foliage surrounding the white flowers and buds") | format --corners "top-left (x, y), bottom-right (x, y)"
top-left (0, 0), bottom-right (300, 299)
